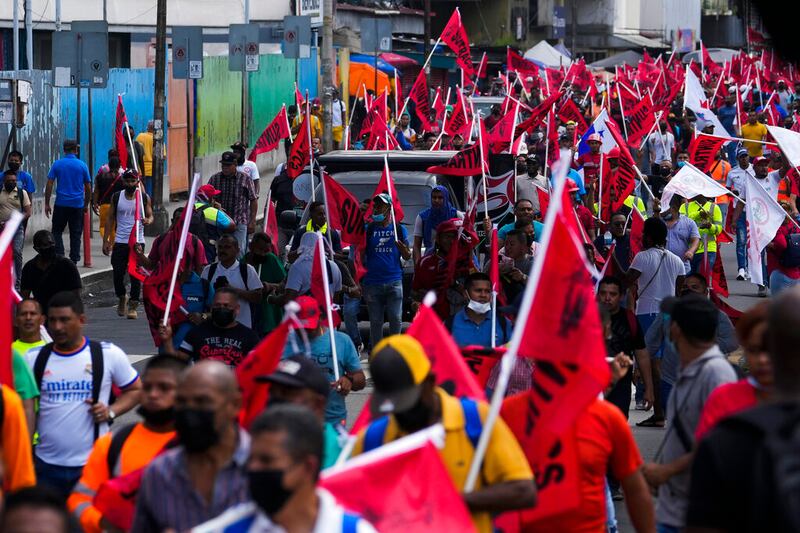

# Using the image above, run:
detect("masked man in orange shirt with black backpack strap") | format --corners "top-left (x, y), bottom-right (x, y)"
top-left (67, 355), bottom-right (186, 533)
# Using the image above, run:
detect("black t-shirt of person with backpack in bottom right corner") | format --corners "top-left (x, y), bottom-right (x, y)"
top-left (686, 403), bottom-right (800, 532)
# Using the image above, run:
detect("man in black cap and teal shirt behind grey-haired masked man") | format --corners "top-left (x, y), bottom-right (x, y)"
top-left (256, 354), bottom-right (347, 469)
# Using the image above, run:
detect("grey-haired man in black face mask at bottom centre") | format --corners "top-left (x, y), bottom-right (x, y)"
top-left (193, 405), bottom-right (375, 533)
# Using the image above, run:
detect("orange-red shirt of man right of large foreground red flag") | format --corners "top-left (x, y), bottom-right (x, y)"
top-left (527, 400), bottom-right (642, 533)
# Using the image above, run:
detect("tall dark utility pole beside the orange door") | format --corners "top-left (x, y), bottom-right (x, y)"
top-left (145, 0), bottom-right (169, 236)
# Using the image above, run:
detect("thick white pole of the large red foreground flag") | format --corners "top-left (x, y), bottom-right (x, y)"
top-left (464, 156), bottom-right (569, 492)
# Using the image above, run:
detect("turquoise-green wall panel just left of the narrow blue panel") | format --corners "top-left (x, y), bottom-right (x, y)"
top-left (248, 54), bottom-right (295, 146)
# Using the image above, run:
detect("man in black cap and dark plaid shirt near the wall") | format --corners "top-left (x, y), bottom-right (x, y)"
top-left (208, 152), bottom-right (258, 255)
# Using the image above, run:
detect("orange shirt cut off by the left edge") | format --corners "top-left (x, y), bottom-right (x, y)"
top-left (0, 385), bottom-right (36, 492)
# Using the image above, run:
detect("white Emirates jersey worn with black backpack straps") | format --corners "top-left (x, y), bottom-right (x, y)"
top-left (25, 339), bottom-right (139, 466)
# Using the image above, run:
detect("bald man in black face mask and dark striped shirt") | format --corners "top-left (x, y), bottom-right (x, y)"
top-left (131, 361), bottom-right (250, 533)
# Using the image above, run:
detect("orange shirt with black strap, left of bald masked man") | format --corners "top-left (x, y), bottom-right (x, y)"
top-left (67, 424), bottom-right (175, 533)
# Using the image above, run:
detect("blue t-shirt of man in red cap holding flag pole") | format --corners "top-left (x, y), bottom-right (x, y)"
top-left (282, 329), bottom-right (361, 424)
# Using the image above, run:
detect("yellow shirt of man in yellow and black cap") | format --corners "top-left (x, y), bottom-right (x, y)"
top-left (353, 387), bottom-right (533, 533)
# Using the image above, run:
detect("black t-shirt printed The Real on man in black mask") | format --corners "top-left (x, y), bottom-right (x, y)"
top-left (178, 320), bottom-right (259, 366)
